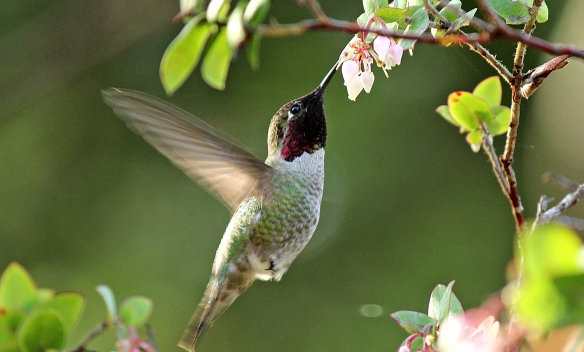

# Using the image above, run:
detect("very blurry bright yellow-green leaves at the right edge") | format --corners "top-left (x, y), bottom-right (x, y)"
top-left (509, 223), bottom-right (584, 333)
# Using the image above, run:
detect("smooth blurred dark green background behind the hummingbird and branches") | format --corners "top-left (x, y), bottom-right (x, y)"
top-left (0, 0), bottom-right (584, 351)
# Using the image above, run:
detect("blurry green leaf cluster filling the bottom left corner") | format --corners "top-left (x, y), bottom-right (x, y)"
top-left (0, 263), bottom-right (85, 352)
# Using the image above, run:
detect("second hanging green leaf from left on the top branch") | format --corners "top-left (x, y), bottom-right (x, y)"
top-left (201, 28), bottom-right (233, 90)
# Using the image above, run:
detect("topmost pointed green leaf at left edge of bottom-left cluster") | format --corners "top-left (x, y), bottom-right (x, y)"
top-left (0, 262), bottom-right (38, 312)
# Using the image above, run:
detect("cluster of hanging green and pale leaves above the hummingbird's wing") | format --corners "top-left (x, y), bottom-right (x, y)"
top-left (160, 0), bottom-right (270, 95)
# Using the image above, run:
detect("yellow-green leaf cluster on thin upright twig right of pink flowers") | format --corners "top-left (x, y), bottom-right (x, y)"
top-left (436, 76), bottom-right (511, 152)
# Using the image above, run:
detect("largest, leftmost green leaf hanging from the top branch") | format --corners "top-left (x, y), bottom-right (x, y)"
top-left (160, 14), bottom-right (217, 95)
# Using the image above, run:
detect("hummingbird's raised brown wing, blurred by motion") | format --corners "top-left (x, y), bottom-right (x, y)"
top-left (102, 88), bottom-right (270, 212)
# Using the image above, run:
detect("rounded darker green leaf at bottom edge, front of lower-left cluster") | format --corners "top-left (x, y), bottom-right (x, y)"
top-left (18, 309), bottom-right (66, 352)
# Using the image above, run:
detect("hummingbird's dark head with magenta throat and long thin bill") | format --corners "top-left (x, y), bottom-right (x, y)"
top-left (268, 63), bottom-right (337, 161)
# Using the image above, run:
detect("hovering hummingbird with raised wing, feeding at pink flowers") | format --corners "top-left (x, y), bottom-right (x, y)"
top-left (102, 63), bottom-right (338, 352)
